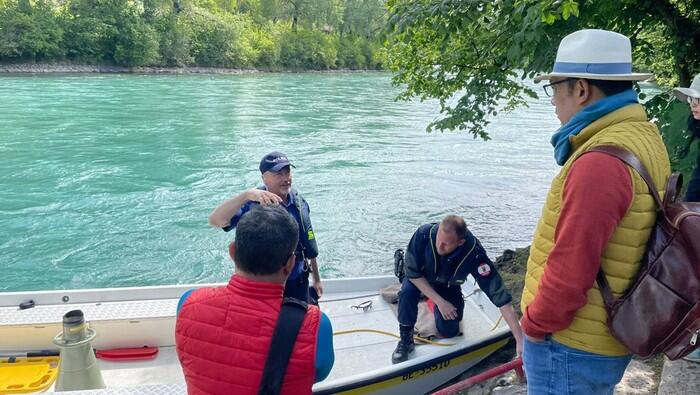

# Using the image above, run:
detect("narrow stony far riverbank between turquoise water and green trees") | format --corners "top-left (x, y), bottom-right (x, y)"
top-left (0, 63), bottom-right (382, 75)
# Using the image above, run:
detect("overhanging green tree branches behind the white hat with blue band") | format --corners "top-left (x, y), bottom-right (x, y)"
top-left (387, 0), bottom-right (700, 139)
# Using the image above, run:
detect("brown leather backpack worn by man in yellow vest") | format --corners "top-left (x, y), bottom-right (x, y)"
top-left (589, 145), bottom-right (700, 360)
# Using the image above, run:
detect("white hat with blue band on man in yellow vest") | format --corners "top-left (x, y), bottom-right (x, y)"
top-left (535, 29), bottom-right (653, 82)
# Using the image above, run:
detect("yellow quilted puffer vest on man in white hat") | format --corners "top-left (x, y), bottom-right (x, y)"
top-left (521, 104), bottom-right (671, 356)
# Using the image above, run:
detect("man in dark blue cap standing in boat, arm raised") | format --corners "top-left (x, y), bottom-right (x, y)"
top-left (209, 151), bottom-right (323, 301)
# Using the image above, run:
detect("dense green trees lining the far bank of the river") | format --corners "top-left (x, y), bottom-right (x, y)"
top-left (0, 0), bottom-right (386, 70)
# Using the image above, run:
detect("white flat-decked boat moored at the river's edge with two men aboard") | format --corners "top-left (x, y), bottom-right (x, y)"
top-left (0, 276), bottom-right (511, 395)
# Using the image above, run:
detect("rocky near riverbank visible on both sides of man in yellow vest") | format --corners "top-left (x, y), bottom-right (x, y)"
top-left (448, 247), bottom-right (668, 395)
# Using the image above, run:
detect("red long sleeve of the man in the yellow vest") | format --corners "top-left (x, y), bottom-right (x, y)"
top-left (521, 152), bottom-right (634, 338)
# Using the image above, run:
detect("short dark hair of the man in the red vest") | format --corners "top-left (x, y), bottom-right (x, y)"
top-left (234, 205), bottom-right (299, 274)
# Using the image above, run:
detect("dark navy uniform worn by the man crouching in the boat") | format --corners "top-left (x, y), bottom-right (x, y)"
top-left (399, 224), bottom-right (512, 337)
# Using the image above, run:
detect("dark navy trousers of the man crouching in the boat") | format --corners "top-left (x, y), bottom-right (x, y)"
top-left (398, 278), bottom-right (464, 337)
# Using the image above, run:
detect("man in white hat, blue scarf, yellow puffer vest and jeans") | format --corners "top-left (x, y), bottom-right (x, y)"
top-left (521, 30), bottom-right (670, 394)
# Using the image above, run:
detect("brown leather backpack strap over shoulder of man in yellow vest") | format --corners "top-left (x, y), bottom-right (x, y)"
top-left (586, 145), bottom-right (660, 314)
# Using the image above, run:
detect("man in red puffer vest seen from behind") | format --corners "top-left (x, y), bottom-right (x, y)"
top-left (175, 205), bottom-right (334, 395)
